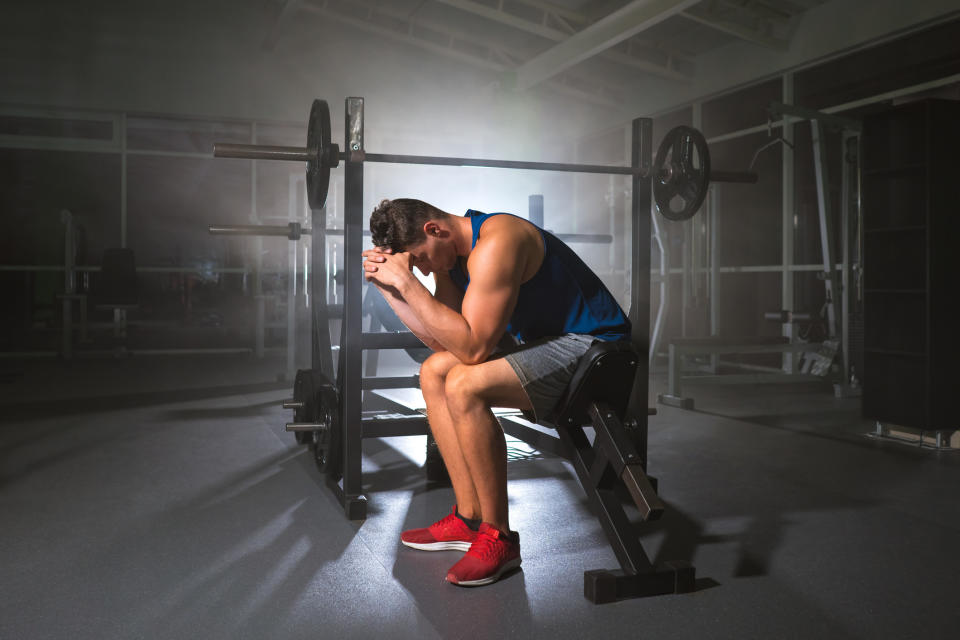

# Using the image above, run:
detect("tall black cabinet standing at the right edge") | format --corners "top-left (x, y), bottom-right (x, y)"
top-left (861, 100), bottom-right (960, 429)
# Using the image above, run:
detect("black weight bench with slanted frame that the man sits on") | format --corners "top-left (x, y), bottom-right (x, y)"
top-left (501, 342), bottom-right (695, 604)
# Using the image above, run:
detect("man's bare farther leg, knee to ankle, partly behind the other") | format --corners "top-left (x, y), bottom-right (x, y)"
top-left (420, 351), bottom-right (483, 520)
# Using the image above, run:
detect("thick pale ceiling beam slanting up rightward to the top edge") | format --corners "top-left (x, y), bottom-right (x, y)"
top-left (514, 0), bottom-right (699, 89)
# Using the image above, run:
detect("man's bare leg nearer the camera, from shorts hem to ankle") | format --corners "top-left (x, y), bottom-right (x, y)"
top-left (438, 358), bottom-right (531, 533)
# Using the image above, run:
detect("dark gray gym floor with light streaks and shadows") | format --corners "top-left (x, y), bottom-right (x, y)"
top-left (0, 356), bottom-right (960, 640)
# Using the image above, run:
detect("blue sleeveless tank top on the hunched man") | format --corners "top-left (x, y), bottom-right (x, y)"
top-left (449, 209), bottom-right (630, 342)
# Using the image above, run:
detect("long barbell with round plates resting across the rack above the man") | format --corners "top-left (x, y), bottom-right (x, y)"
top-left (213, 99), bottom-right (757, 220)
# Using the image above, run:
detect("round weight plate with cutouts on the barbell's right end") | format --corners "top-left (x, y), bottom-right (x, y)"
top-left (653, 126), bottom-right (710, 220)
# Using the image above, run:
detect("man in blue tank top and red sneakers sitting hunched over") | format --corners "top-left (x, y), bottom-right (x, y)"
top-left (363, 199), bottom-right (630, 586)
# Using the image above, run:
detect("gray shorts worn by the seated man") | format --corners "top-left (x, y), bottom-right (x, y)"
top-left (503, 333), bottom-right (599, 422)
